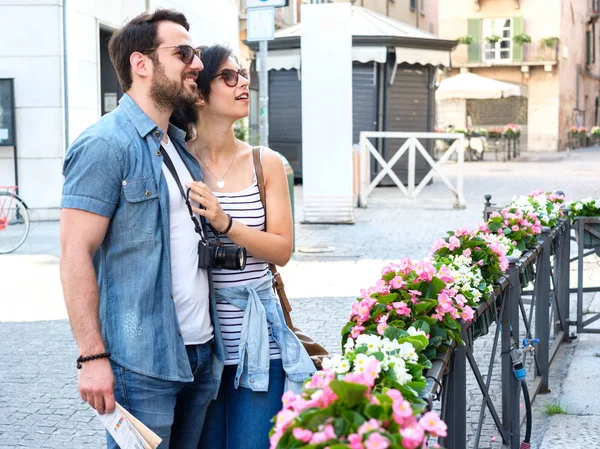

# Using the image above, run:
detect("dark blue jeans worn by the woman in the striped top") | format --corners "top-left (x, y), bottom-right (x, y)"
top-left (198, 359), bottom-right (285, 449)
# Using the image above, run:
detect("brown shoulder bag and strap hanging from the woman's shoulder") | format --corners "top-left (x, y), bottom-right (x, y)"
top-left (252, 147), bottom-right (329, 369)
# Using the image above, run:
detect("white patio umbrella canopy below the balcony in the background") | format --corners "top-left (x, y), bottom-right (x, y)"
top-left (435, 72), bottom-right (522, 100)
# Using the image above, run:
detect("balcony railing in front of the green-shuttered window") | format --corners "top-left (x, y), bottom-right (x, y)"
top-left (451, 42), bottom-right (558, 67)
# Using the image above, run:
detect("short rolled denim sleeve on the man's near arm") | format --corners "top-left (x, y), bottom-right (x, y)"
top-left (60, 135), bottom-right (123, 217)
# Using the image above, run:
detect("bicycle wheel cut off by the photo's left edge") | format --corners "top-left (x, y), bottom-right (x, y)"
top-left (0, 186), bottom-right (30, 254)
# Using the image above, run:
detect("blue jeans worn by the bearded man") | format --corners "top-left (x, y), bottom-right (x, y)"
top-left (106, 341), bottom-right (215, 449)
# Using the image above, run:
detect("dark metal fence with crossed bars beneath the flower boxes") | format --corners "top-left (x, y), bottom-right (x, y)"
top-left (426, 197), bottom-right (571, 449)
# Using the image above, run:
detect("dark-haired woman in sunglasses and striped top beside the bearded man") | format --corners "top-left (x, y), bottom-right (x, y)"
top-left (171, 45), bottom-right (314, 449)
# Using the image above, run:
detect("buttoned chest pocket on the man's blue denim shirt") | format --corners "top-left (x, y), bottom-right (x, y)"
top-left (123, 177), bottom-right (160, 237)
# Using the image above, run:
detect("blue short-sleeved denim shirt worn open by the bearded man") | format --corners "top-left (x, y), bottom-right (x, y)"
top-left (61, 94), bottom-right (225, 382)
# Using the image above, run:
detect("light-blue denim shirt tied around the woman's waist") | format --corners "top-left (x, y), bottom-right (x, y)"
top-left (213, 273), bottom-right (315, 393)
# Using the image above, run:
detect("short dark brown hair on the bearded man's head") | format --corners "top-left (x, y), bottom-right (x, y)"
top-left (108, 9), bottom-right (190, 92)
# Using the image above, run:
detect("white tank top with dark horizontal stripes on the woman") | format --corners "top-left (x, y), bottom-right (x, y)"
top-left (207, 168), bottom-right (281, 365)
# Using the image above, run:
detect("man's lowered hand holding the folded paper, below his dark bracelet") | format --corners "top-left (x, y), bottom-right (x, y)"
top-left (77, 359), bottom-right (115, 415)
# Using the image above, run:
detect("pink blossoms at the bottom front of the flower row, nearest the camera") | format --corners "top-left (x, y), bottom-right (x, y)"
top-left (270, 370), bottom-right (448, 449)
